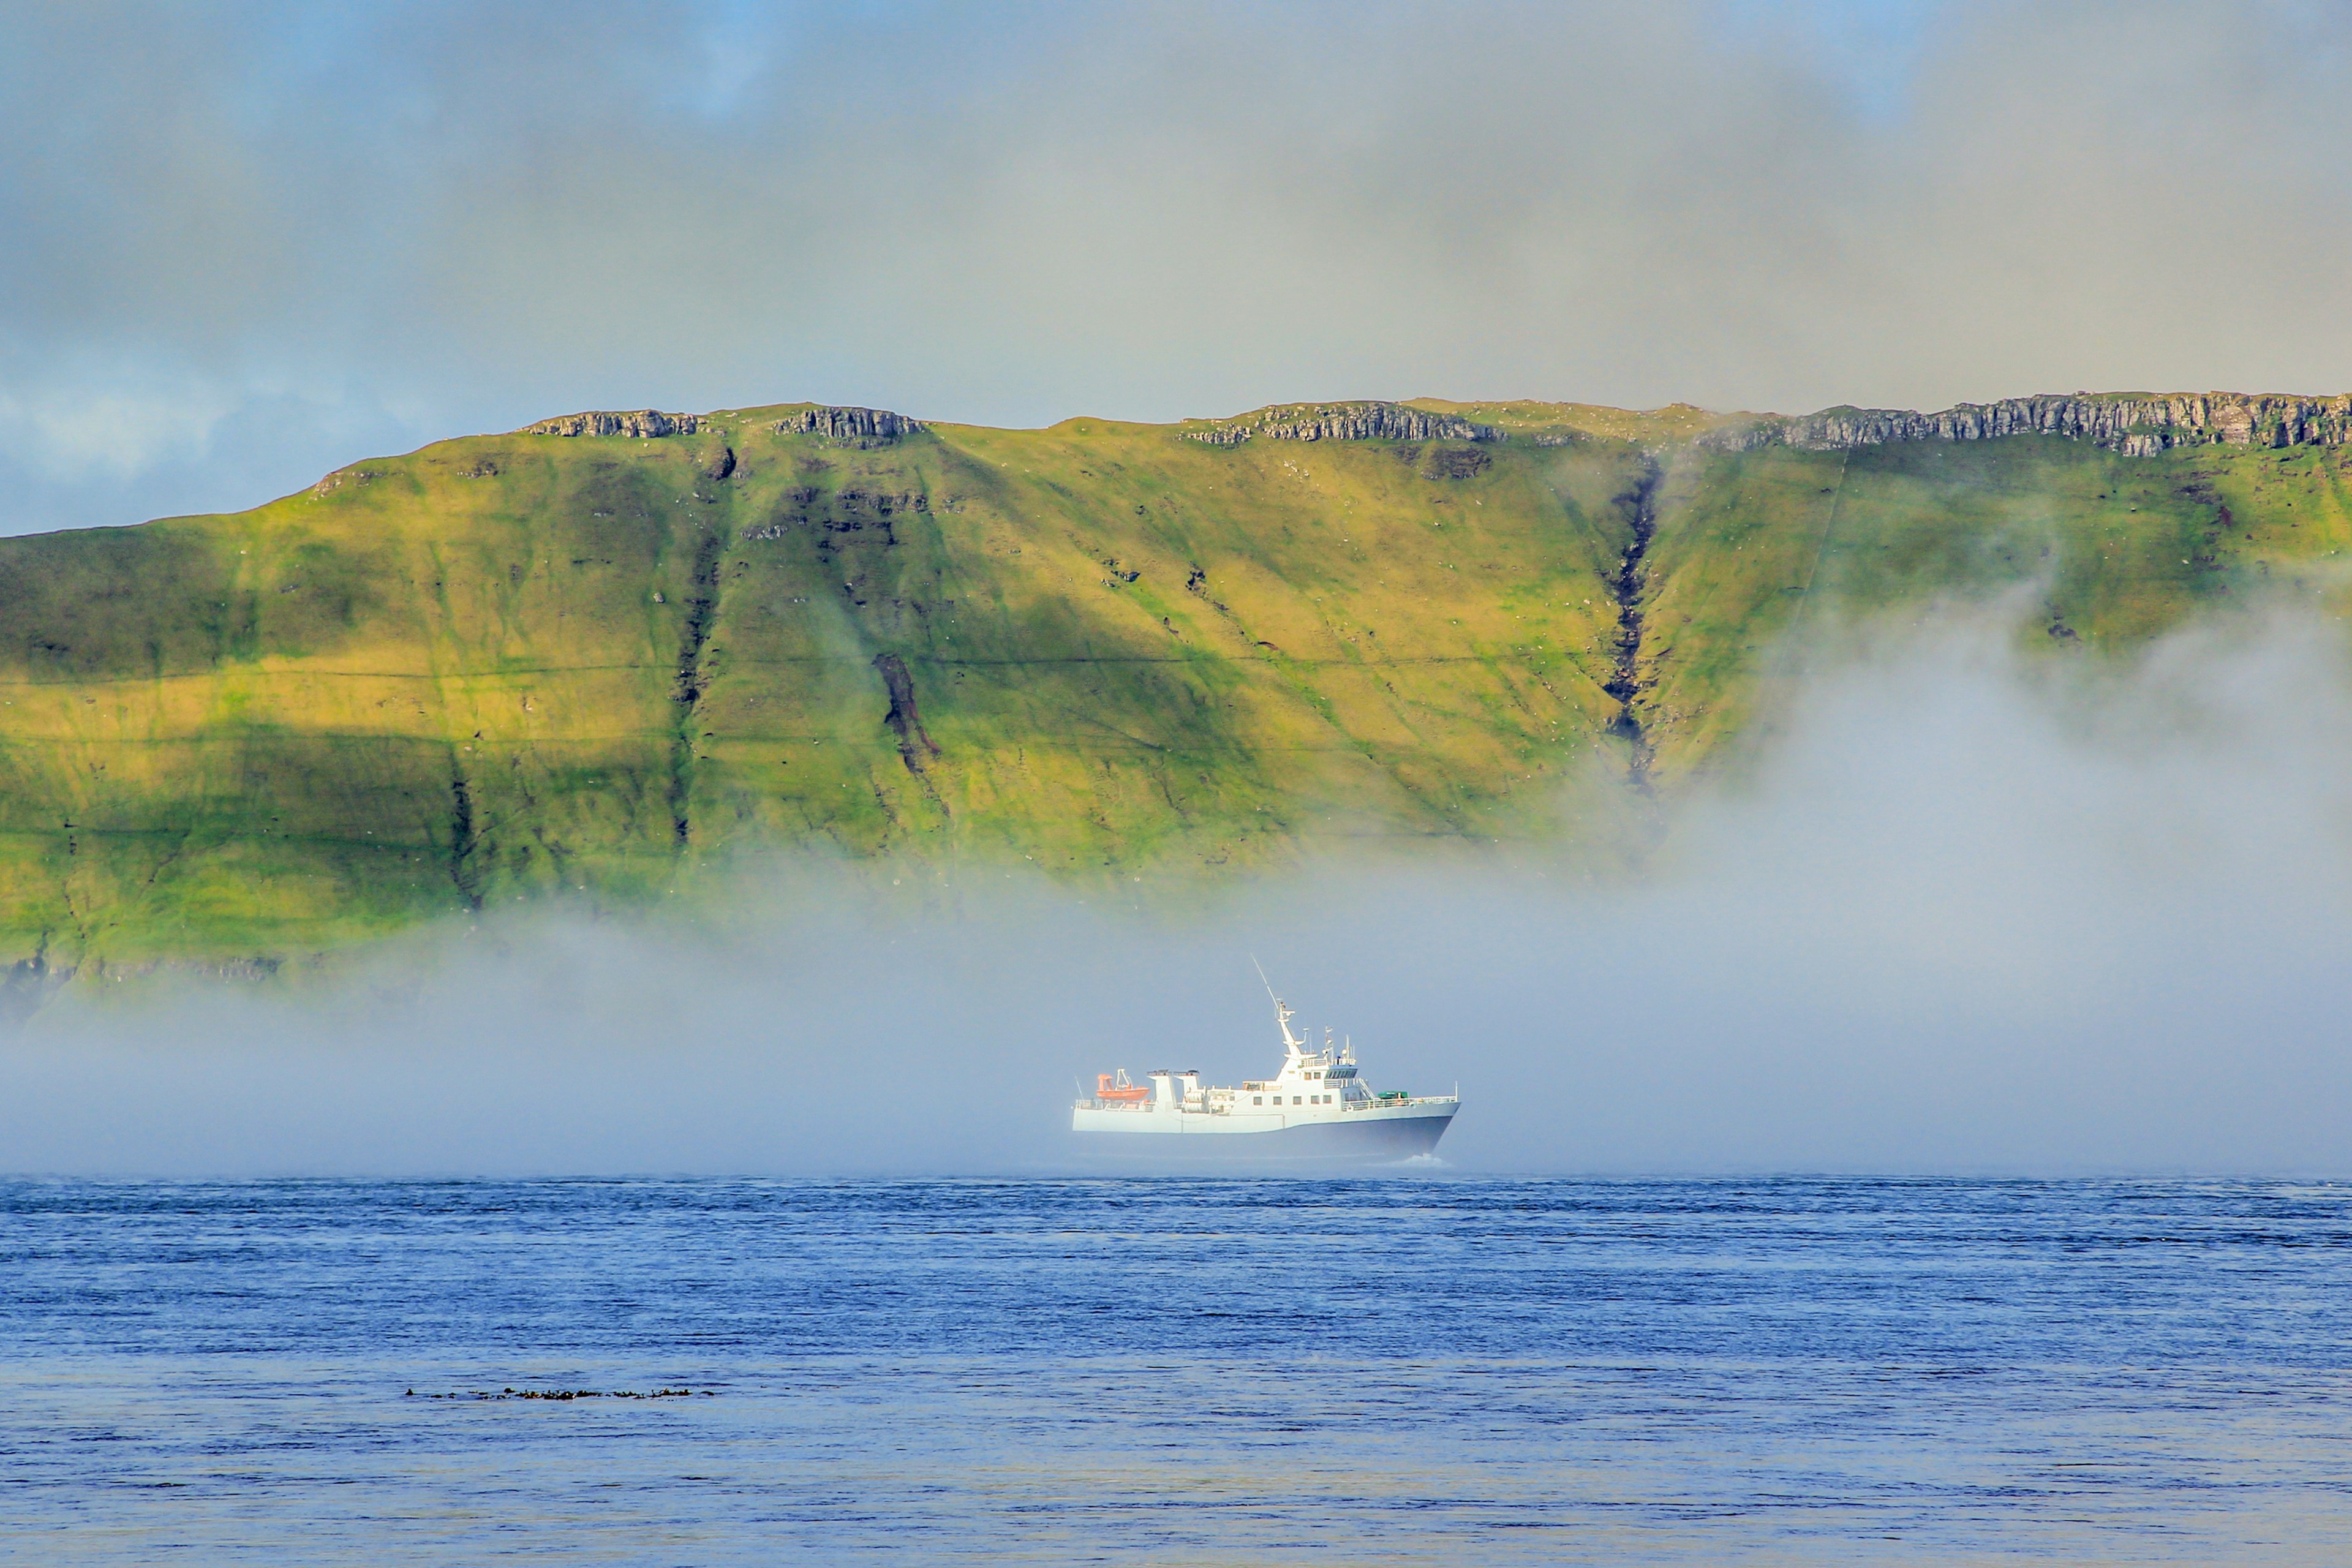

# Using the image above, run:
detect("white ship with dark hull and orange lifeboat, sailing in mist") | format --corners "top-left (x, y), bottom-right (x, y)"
top-left (1070, 997), bottom-right (1461, 1164)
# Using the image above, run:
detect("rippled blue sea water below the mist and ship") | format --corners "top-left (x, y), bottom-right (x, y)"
top-left (0, 1175), bottom-right (2352, 1563)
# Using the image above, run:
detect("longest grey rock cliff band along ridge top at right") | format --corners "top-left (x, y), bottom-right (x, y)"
top-left (1698, 393), bottom-right (2352, 456)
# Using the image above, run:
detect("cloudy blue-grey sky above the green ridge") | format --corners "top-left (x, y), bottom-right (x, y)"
top-left (0, 0), bottom-right (2352, 533)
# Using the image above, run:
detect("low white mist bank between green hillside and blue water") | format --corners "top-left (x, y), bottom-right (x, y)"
top-left (0, 618), bottom-right (2352, 1173)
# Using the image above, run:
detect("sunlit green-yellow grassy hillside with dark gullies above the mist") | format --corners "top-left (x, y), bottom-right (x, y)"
top-left (0, 402), bottom-right (2352, 964)
